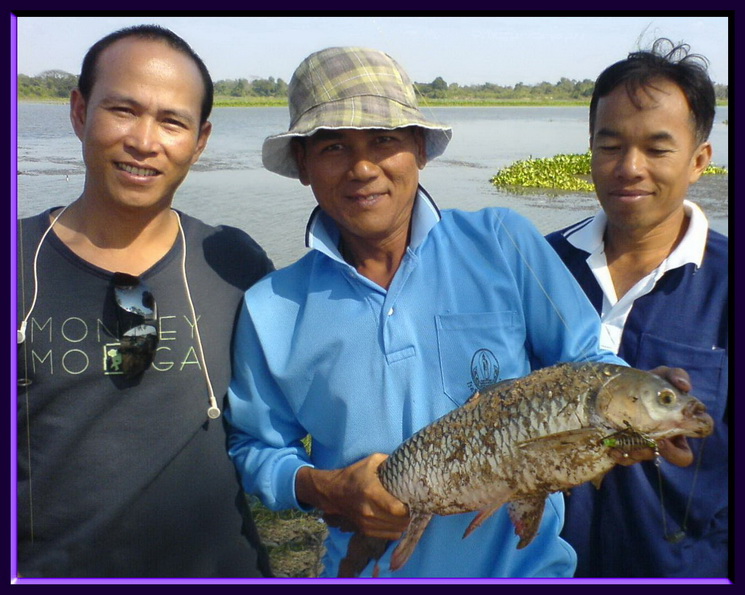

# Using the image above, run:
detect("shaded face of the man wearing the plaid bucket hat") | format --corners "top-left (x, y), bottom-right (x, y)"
top-left (295, 128), bottom-right (426, 245)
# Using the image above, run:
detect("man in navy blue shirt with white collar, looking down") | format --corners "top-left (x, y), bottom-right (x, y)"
top-left (547, 39), bottom-right (729, 577)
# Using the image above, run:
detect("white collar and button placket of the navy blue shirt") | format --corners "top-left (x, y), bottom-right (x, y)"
top-left (567, 200), bottom-right (709, 354)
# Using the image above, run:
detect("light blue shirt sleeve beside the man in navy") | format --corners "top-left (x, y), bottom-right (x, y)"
top-left (497, 211), bottom-right (628, 369)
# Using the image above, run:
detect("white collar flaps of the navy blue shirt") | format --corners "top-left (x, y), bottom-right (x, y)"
top-left (564, 200), bottom-right (709, 269)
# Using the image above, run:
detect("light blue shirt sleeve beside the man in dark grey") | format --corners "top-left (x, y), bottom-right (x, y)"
top-left (225, 299), bottom-right (312, 510)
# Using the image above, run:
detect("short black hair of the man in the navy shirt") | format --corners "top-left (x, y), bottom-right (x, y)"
top-left (590, 38), bottom-right (716, 143)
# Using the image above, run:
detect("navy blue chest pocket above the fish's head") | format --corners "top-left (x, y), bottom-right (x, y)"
top-left (635, 333), bottom-right (729, 421)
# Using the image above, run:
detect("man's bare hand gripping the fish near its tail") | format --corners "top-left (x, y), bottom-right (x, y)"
top-left (295, 453), bottom-right (409, 539)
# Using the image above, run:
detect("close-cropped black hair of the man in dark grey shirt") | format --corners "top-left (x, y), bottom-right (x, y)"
top-left (78, 25), bottom-right (214, 124)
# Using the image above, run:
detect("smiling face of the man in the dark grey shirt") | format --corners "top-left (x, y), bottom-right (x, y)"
top-left (70, 37), bottom-right (210, 209)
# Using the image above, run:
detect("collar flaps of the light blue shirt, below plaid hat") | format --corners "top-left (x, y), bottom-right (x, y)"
top-left (305, 186), bottom-right (441, 262)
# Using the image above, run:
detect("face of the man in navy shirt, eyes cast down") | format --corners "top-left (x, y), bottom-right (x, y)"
top-left (590, 80), bottom-right (711, 232)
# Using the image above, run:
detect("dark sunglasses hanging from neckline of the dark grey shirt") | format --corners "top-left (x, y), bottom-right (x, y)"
top-left (114, 273), bottom-right (158, 378)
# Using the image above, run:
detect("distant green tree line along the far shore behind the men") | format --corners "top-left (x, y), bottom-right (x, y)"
top-left (18, 70), bottom-right (729, 102)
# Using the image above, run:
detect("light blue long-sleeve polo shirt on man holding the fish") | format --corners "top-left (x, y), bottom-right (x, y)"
top-left (228, 189), bottom-right (623, 577)
